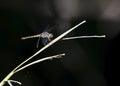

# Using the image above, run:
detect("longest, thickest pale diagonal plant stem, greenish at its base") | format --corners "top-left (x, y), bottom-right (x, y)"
top-left (0, 20), bottom-right (86, 86)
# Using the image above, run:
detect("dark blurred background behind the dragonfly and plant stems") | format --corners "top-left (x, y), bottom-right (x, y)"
top-left (0, 0), bottom-right (120, 86)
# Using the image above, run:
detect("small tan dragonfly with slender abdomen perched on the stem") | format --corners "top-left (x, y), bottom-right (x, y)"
top-left (21, 27), bottom-right (53, 48)
